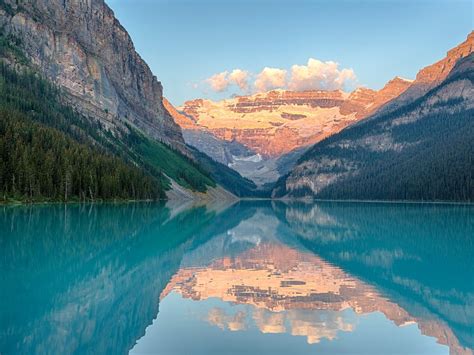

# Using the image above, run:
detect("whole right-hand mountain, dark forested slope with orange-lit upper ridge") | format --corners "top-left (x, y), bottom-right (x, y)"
top-left (273, 33), bottom-right (474, 201)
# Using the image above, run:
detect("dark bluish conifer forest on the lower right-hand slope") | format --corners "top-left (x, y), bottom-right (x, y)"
top-left (312, 110), bottom-right (474, 201)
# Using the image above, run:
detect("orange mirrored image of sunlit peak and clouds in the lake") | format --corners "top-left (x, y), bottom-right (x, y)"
top-left (161, 242), bottom-right (469, 354)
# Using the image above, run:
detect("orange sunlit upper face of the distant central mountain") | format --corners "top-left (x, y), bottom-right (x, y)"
top-left (170, 78), bottom-right (410, 158)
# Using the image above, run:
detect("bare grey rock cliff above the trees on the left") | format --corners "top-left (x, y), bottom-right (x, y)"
top-left (0, 0), bottom-right (185, 151)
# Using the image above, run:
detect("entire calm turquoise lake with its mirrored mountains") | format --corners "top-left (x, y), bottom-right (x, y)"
top-left (0, 201), bottom-right (474, 355)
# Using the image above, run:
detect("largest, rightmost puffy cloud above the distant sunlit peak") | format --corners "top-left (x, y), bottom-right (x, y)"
top-left (288, 58), bottom-right (356, 91)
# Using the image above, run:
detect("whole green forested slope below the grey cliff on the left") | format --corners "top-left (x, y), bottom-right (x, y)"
top-left (0, 37), bottom-right (215, 201)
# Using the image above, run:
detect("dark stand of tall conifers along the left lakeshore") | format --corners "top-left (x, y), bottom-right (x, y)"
top-left (0, 107), bottom-right (165, 201)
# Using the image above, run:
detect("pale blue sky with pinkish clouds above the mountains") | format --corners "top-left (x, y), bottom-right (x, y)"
top-left (106, 0), bottom-right (474, 105)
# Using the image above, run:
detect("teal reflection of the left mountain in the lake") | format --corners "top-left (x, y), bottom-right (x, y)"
top-left (0, 204), bottom-right (237, 354)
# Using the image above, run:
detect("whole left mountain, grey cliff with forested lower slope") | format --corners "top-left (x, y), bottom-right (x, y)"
top-left (0, 0), bottom-right (236, 201)
